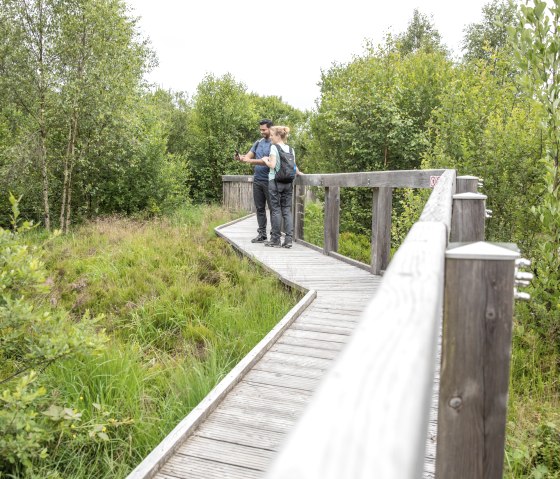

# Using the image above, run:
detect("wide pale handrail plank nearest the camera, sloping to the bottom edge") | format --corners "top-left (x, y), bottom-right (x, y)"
top-left (267, 223), bottom-right (447, 479)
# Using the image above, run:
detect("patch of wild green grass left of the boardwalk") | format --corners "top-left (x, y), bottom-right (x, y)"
top-left (26, 207), bottom-right (301, 478)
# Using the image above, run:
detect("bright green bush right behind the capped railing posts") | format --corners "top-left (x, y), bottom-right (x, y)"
top-left (423, 51), bottom-right (542, 250)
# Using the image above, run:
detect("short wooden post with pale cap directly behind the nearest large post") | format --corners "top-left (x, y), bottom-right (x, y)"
top-left (449, 193), bottom-right (487, 242)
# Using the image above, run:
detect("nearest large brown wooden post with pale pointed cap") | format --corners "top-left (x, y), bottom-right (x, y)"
top-left (436, 242), bottom-right (519, 479)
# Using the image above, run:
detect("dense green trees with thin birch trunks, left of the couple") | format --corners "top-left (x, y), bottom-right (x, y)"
top-left (0, 0), bottom-right (305, 231)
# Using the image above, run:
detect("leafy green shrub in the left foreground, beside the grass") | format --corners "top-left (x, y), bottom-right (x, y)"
top-left (0, 195), bottom-right (104, 477)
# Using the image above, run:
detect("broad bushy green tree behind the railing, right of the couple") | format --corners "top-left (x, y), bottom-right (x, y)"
top-left (307, 29), bottom-right (452, 235)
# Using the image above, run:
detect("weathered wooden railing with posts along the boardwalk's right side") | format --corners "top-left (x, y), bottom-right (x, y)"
top-left (223, 170), bottom-right (519, 479)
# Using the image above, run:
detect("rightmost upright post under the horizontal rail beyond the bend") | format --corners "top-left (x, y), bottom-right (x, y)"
top-left (371, 187), bottom-right (393, 274)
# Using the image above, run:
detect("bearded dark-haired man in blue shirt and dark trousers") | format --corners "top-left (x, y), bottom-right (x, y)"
top-left (239, 119), bottom-right (272, 243)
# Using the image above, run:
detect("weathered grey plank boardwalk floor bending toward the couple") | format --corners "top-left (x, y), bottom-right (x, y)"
top-left (129, 216), bottom-right (437, 479)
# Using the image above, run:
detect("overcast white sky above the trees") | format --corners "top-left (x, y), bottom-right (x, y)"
top-left (127, 0), bottom-right (489, 109)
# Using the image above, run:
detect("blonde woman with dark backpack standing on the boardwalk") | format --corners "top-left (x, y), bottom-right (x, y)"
top-left (262, 126), bottom-right (300, 248)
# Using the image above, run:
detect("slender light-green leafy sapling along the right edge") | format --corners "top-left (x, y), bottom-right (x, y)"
top-left (510, 0), bottom-right (560, 312)
